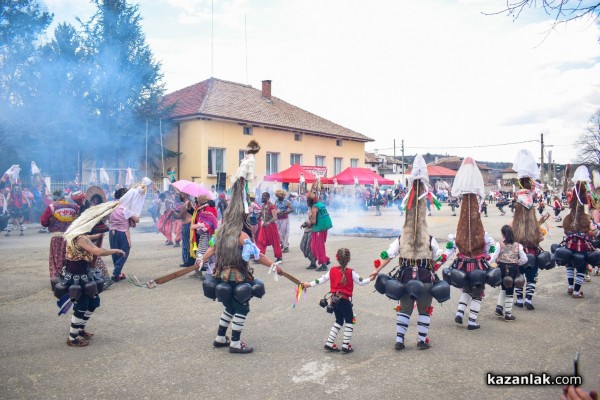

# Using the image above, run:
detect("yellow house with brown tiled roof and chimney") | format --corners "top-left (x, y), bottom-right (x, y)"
top-left (165, 78), bottom-right (373, 189)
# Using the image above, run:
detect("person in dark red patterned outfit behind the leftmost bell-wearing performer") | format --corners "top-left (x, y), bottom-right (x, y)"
top-left (40, 190), bottom-right (79, 279)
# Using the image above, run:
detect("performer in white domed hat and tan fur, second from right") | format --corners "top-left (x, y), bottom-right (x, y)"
top-left (512, 149), bottom-right (550, 310)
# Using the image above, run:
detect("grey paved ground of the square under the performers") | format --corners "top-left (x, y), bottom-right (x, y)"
top-left (0, 207), bottom-right (600, 399)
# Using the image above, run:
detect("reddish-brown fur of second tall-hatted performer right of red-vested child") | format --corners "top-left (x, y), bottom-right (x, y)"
top-left (456, 193), bottom-right (485, 257)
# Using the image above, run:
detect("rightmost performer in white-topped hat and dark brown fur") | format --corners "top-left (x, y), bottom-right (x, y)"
top-left (563, 165), bottom-right (595, 298)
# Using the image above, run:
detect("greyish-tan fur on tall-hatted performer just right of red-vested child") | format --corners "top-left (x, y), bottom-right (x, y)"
top-left (400, 180), bottom-right (431, 260)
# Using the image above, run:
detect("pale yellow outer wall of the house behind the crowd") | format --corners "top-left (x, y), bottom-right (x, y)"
top-left (165, 120), bottom-right (365, 185)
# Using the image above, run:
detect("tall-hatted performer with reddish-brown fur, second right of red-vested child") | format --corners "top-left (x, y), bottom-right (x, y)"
top-left (444, 157), bottom-right (495, 330)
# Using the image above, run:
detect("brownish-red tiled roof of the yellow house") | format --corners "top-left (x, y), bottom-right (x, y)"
top-left (164, 78), bottom-right (373, 142)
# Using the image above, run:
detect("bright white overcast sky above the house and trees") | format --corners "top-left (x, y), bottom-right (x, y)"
top-left (47, 0), bottom-right (600, 163)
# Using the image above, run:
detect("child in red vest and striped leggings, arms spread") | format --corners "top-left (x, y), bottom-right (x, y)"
top-left (302, 248), bottom-right (371, 353)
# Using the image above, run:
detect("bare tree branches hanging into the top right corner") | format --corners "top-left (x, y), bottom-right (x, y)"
top-left (484, 0), bottom-right (600, 28)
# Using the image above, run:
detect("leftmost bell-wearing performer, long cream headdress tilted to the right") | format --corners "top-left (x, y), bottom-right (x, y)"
top-left (54, 202), bottom-right (125, 347)
